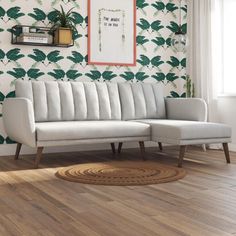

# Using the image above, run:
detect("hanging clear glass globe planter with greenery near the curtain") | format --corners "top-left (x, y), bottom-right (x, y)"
top-left (171, 0), bottom-right (187, 52)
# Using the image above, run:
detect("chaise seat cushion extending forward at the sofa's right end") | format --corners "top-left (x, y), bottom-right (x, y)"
top-left (136, 120), bottom-right (231, 144)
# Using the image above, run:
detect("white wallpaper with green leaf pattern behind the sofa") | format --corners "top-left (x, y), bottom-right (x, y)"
top-left (0, 0), bottom-right (187, 144)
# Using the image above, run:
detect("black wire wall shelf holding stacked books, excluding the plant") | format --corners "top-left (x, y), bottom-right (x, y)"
top-left (11, 25), bottom-right (74, 48)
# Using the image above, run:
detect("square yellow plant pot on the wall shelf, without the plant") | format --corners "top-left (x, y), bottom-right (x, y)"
top-left (54, 27), bottom-right (73, 45)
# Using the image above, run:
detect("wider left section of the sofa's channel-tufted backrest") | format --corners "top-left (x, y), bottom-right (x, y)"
top-left (16, 81), bottom-right (121, 122)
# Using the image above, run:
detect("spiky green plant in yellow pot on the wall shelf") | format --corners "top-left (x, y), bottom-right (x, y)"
top-left (50, 6), bottom-right (78, 45)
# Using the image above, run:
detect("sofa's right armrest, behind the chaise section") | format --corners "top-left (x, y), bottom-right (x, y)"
top-left (165, 98), bottom-right (207, 121)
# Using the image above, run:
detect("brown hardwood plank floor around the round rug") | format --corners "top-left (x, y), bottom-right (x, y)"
top-left (0, 146), bottom-right (236, 236)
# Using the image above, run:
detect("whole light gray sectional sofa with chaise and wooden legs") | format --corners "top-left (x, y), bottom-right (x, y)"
top-left (3, 81), bottom-right (231, 168)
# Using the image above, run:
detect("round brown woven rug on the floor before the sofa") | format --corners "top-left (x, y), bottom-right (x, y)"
top-left (56, 161), bottom-right (186, 186)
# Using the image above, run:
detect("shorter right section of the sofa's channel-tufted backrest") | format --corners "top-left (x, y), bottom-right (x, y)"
top-left (118, 83), bottom-right (166, 120)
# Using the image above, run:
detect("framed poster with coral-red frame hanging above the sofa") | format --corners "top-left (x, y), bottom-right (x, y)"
top-left (88, 0), bottom-right (136, 66)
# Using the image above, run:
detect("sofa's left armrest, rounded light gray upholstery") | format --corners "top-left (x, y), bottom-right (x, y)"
top-left (3, 98), bottom-right (36, 147)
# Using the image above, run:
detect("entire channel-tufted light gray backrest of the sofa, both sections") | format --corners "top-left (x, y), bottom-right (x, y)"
top-left (16, 81), bottom-right (166, 122)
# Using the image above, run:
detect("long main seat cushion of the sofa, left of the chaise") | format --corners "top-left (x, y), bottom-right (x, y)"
top-left (36, 121), bottom-right (150, 141)
